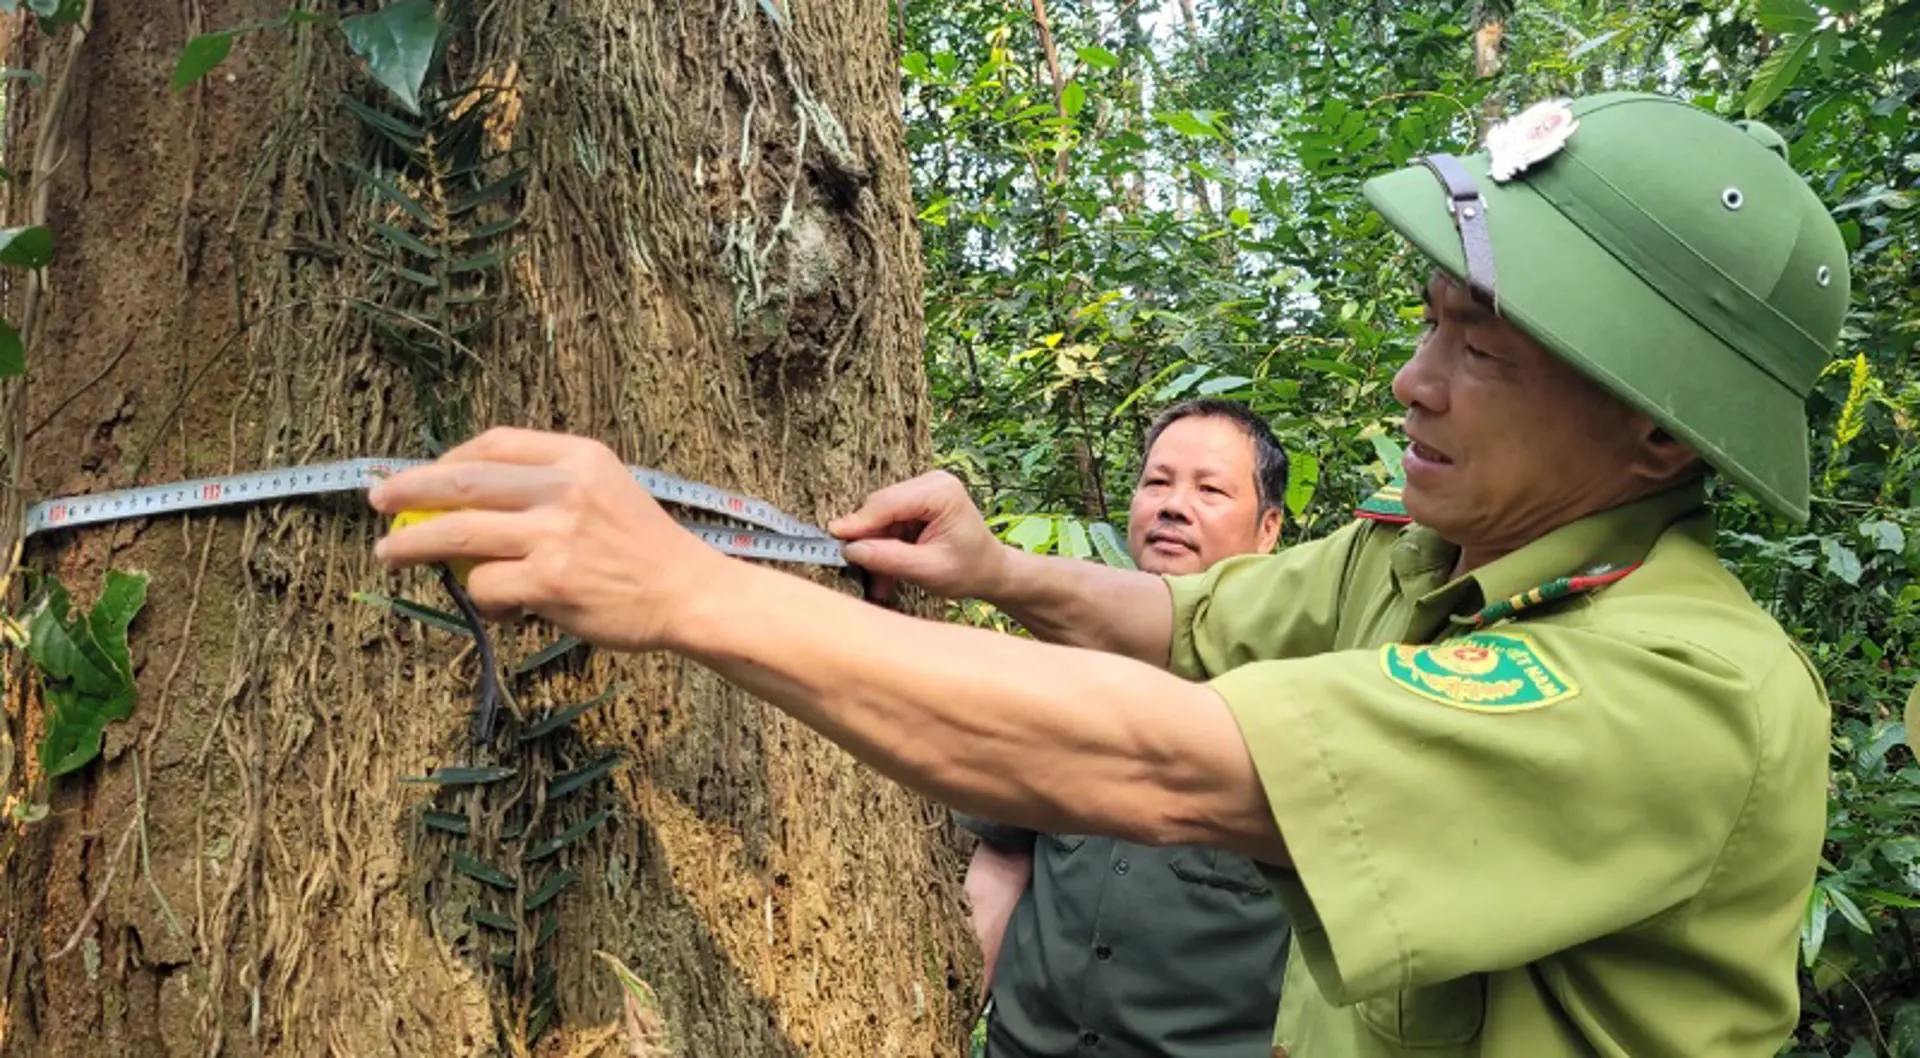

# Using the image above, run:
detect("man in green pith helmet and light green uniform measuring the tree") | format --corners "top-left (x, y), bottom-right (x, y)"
top-left (371, 94), bottom-right (1849, 1058)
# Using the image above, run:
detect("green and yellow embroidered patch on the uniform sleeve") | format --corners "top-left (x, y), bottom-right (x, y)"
top-left (1380, 632), bottom-right (1580, 712)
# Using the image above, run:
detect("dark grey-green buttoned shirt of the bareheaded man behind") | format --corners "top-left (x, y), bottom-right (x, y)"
top-left (956, 814), bottom-right (1286, 1058)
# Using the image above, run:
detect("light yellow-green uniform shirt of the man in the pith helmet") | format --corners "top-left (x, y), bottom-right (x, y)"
top-left (1171, 486), bottom-right (1828, 1058)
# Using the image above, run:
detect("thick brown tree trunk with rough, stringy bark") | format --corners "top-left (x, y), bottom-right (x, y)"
top-left (0, 0), bottom-right (977, 1056)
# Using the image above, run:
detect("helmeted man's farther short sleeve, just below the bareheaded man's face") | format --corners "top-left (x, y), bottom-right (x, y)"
top-left (1165, 520), bottom-right (1373, 680)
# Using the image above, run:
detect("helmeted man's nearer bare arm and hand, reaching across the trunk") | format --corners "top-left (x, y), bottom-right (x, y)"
top-left (371, 430), bottom-right (1286, 862)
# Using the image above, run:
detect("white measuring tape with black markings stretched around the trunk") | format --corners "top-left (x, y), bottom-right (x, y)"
top-left (25, 459), bottom-right (847, 566)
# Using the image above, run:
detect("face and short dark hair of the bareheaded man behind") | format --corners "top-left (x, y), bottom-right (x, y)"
top-left (1127, 415), bottom-right (1281, 574)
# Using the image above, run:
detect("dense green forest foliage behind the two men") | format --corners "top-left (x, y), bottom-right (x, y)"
top-left (902, 0), bottom-right (1920, 1058)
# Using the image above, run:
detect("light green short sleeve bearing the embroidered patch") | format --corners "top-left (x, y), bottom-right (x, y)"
top-left (1212, 624), bottom-right (1774, 1004)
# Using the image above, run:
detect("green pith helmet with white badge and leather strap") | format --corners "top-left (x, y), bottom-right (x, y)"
top-left (1363, 92), bottom-right (1849, 522)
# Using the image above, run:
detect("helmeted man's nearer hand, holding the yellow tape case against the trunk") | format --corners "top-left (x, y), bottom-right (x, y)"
top-left (367, 428), bottom-right (726, 651)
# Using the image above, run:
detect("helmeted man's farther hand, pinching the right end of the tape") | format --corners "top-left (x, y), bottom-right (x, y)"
top-left (828, 470), bottom-right (1006, 601)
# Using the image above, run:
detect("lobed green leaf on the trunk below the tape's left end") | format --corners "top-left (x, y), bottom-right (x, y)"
top-left (23, 570), bottom-right (146, 778)
